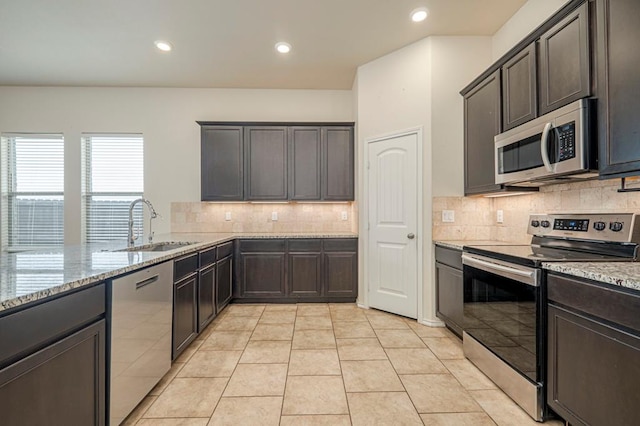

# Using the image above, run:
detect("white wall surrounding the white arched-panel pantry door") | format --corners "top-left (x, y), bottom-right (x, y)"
top-left (354, 37), bottom-right (491, 323)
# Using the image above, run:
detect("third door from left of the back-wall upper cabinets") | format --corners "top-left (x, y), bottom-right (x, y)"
top-left (289, 127), bottom-right (322, 200)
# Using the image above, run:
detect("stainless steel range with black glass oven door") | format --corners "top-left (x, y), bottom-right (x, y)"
top-left (462, 213), bottom-right (640, 421)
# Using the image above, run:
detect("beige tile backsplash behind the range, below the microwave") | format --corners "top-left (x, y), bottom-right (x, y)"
top-left (433, 179), bottom-right (640, 243)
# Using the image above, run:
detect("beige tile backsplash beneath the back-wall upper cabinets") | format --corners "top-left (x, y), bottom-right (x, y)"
top-left (171, 202), bottom-right (358, 233)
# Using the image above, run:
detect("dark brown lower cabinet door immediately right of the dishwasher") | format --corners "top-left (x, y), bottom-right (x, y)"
top-left (171, 272), bottom-right (198, 359)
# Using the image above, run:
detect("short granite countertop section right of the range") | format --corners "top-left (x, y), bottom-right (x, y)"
top-left (542, 262), bottom-right (640, 290)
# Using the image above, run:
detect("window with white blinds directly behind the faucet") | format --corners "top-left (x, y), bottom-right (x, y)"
top-left (82, 134), bottom-right (144, 243)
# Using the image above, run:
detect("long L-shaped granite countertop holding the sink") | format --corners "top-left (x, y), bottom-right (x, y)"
top-left (0, 232), bottom-right (358, 312)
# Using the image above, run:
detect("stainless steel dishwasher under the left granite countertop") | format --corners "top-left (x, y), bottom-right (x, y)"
top-left (109, 261), bottom-right (173, 426)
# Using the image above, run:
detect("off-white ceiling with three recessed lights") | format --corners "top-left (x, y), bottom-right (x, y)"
top-left (0, 0), bottom-right (526, 89)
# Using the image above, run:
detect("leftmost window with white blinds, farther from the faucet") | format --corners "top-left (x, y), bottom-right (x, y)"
top-left (1, 134), bottom-right (64, 251)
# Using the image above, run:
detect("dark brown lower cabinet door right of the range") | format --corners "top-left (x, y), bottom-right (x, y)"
top-left (547, 305), bottom-right (640, 425)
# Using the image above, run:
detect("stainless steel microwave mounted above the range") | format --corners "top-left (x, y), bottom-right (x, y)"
top-left (495, 99), bottom-right (598, 186)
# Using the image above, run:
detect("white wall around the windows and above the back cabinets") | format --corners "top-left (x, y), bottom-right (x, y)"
top-left (0, 87), bottom-right (354, 244)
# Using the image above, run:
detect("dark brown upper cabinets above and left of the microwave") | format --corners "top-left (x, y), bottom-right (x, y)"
top-left (461, 0), bottom-right (593, 195)
